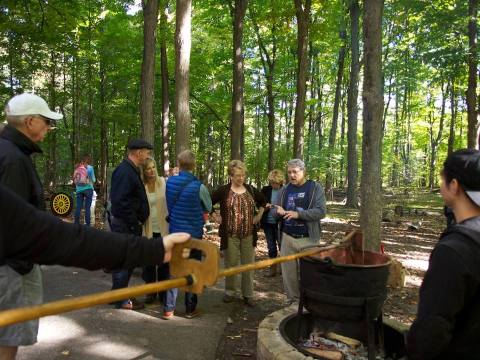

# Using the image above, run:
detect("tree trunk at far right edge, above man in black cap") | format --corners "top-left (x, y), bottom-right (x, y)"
top-left (467, 0), bottom-right (478, 149)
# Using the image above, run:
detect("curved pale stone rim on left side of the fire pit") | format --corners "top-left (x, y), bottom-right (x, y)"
top-left (257, 305), bottom-right (314, 360)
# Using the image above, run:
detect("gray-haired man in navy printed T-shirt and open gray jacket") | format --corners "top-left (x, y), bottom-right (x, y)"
top-left (274, 159), bottom-right (326, 303)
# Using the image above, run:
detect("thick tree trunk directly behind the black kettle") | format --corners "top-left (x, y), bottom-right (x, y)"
top-left (360, 0), bottom-right (383, 250)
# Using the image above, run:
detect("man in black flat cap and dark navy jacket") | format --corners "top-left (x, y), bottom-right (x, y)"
top-left (110, 139), bottom-right (153, 310)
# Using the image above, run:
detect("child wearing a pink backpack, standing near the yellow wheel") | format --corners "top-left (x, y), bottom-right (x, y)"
top-left (73, 155), bottom-right (96, 226)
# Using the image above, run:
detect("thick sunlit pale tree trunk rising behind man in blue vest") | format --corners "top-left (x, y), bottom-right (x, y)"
top-left (175, 0), bottom-right (192, 155)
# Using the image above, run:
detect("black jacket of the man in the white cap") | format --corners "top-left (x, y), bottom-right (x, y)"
top-left (0, 125), bottom-right (45, 274)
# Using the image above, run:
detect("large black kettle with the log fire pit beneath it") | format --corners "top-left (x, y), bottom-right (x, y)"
top-left (258, 232), bottom-right (404, 360)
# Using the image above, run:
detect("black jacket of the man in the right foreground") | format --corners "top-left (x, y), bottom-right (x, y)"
top-left (407, 217), bottom-right (480, 360)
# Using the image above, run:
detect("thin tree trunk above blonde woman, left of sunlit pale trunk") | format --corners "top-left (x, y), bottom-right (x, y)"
top-left (160, 1), bottom-right (170, 176)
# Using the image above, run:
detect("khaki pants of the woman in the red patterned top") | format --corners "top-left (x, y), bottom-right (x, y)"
top-left (225, 235), bottom-right (255, 298)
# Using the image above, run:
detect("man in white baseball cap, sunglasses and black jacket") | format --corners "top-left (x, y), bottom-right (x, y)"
top-left (0, 93), bottom-right (63, 360)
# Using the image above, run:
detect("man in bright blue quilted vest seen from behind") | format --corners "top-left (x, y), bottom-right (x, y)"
top-left (163, 150), bottom-right (212, 320)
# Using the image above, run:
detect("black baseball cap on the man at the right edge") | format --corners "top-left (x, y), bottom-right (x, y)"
top-left (443, 149), bottom-right (480, 206)
